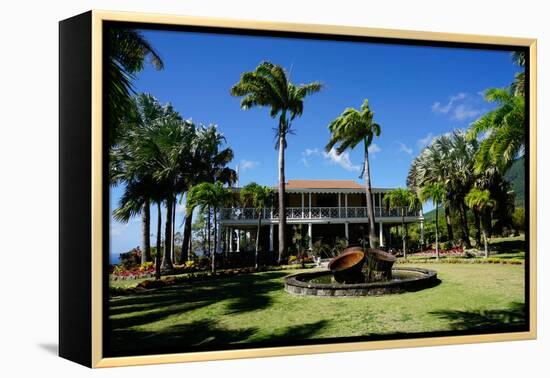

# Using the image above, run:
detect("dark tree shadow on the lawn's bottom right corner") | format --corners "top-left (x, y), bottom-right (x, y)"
top-left (430, 302), bottom-right (527, 331)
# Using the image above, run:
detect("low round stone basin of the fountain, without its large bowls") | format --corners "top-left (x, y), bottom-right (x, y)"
top-left (285, 267), bottom-right (439, 297)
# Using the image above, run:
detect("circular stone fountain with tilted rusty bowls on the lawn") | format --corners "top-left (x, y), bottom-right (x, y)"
top-left (285, 247), bottom-right (439, 297)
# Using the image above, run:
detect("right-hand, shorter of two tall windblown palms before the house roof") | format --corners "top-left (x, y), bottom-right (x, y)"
top-left (325, 99), bottom-right (380, 248)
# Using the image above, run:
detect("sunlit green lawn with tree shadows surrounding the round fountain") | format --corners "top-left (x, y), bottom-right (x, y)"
top-left (109, 264), bottom-right (524, 354)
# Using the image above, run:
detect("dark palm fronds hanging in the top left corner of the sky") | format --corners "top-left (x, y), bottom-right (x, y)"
top-left (107, 27), bottom-right (164, 146)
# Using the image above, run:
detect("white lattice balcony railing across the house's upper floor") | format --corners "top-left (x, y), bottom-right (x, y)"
top-left (221, 207), bottom-right (420, 220)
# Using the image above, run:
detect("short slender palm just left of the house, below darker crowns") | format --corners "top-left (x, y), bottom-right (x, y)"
top-left (186, 182), bottom-right (232, 272)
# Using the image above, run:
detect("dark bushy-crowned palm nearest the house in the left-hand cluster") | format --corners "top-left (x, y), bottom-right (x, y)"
top-left (179, 125), bottom-right (237, 264)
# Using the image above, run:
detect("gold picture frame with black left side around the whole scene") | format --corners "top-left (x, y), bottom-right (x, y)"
top-left (60, 10), bottom-right (537, 368)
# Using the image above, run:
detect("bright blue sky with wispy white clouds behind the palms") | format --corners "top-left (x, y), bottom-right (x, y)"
top-left (111, 31), bottom-right (519, 257)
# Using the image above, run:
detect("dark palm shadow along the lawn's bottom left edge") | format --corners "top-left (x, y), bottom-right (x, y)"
top-left (108, 319), bottom-right (327, 356)
